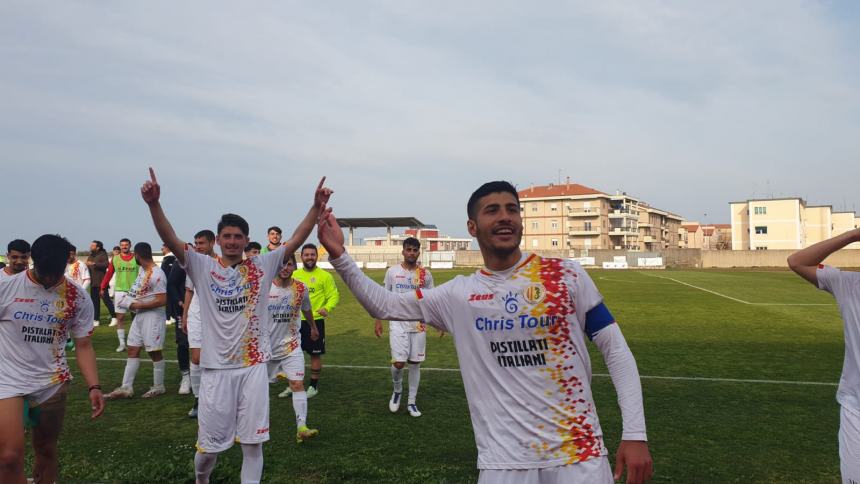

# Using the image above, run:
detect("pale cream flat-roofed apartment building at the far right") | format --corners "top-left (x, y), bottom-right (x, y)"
top-left (729, 198), bottom-right (860, 250)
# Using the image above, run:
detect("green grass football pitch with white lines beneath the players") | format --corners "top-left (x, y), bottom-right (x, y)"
top-left (28, 270), bottom-right (843, 483)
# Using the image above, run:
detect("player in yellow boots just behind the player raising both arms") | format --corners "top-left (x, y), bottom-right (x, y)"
top-left (267, 254), bottom-right (319, 443)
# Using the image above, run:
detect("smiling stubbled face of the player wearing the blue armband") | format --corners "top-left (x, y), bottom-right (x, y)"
top-left (466, 192), bottom-right (523, 255)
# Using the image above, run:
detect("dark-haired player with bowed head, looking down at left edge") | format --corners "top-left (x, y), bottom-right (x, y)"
top-left (0, 235), bottom-right (104, 483)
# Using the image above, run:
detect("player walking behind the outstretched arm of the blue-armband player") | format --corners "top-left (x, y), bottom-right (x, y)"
top-left (374, 237), bottom-right (433, 417)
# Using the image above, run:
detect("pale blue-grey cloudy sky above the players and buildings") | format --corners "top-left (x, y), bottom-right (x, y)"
top-left (0, 0), bottom-right (860, 247)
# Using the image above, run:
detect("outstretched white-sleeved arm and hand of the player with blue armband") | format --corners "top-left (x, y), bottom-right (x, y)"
top-left (317, 211), bottom-right (432, 324)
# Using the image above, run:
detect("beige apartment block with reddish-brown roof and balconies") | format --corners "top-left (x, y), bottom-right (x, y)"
top-left (519, 181), bottom-right (682, 251)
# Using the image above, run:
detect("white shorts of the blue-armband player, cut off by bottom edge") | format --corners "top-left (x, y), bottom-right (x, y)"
top-left (478, 456), bottom-right (615, 484)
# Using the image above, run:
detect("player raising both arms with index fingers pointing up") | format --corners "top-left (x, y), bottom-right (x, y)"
top-left (140, 168), bottom-right (331, 484)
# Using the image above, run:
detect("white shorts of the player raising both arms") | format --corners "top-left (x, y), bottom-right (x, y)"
top-left (197, 365), bottom-right (269, 453)
